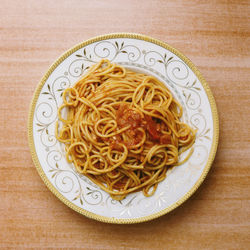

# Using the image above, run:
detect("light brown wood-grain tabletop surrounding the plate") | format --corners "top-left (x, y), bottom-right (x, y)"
top-left (0, 0), bottom-right (250, 249)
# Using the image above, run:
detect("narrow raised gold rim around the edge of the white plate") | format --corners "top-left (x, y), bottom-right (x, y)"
top-left (28, 33), bottom-right (219, 224)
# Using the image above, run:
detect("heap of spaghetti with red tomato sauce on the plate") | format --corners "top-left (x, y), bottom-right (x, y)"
top-left (56, 60), bottom-right (195, 200)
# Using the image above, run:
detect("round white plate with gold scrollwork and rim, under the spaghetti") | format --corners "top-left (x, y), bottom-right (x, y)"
top-left (28, 33), bottom-right (219, 223)
